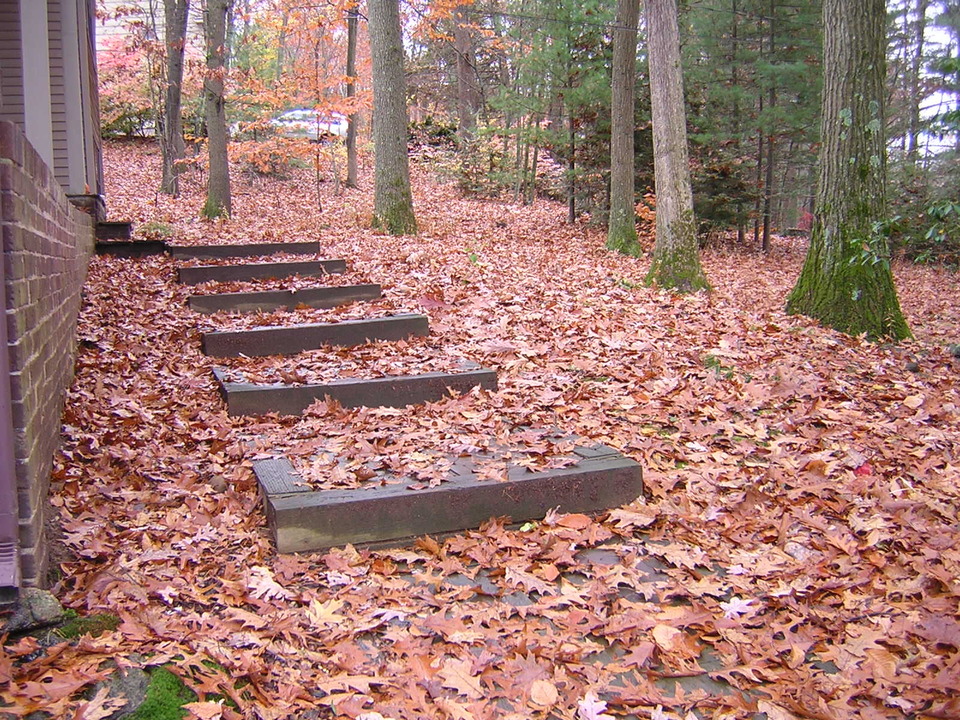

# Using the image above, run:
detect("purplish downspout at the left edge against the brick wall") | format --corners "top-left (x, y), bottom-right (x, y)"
top-left (0, 228), bottom-right (20, 605)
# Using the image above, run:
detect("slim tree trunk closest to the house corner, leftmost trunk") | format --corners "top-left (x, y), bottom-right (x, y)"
top-left (160, 0), bottom-right (190, 197)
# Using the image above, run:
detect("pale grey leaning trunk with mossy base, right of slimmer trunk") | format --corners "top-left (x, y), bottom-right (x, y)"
top-left (646, 0), bottom-right (709, 292)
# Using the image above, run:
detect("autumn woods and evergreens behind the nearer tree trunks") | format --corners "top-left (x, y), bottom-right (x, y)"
top-left (99, 0), bottom-right (960, 262)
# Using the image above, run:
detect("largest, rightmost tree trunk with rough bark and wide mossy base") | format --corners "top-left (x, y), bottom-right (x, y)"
top-left (787, 0), bottom-right (910, 339)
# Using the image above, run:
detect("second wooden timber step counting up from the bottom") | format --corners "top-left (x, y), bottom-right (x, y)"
top-left (213, 366), bottom-right (497, 415)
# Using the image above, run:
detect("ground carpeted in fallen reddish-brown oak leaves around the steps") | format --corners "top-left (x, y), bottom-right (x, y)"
top-left (0, 143), bottom-right (960, 720)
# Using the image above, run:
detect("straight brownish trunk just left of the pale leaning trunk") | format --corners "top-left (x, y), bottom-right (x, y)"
top-left (607, 0), bottom-right (640, 256)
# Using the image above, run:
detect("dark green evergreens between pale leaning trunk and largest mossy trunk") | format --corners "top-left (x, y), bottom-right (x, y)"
top-left (684, 0), bottom-right (821, 240)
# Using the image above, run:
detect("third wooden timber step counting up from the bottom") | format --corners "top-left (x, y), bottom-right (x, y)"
top-left (201, 314), bottom-right (430, 357)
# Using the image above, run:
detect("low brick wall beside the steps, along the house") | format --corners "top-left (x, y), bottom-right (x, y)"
top-left (0, 122), bottom-right (94, 585)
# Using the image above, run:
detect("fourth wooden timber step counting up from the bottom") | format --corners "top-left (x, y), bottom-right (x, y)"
top-left (187, 285), bottom-right (383, 313)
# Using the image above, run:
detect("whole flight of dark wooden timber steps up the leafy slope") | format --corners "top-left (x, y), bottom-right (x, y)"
top-left (165, 242), bottom-right (643, 552)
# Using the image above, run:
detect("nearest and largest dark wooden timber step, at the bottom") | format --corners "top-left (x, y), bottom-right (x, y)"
top-left (253, 441), bottom-right (643, 553)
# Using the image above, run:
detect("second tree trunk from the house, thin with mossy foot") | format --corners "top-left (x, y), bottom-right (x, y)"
top-left (202, 0), bottom-right (233, 218)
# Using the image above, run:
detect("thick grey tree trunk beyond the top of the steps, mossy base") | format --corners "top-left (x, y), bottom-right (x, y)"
top-left (367, 0), bottom-right (417, 235)
